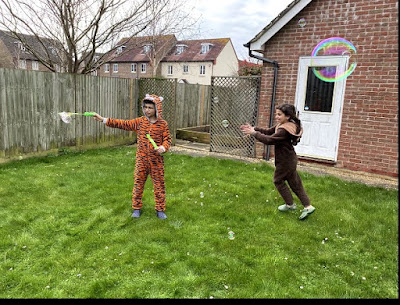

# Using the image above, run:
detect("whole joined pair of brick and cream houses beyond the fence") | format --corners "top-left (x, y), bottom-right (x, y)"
top-left (97, 35), bottom-right (239, 85)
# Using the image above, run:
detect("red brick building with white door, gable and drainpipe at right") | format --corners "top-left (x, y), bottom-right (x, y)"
top-left (245, 0), bottom-right (399, 177)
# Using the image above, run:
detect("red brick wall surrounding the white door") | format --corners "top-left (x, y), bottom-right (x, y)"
top-left (257, 0), bottom-right (398, 176)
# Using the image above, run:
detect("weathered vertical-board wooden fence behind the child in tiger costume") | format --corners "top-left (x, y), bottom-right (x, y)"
top-left (0, 69), bottom-right (211, 157)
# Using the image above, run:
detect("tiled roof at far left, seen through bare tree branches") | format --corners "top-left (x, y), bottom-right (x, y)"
top-left (0, 30), bottom-right (59, 62)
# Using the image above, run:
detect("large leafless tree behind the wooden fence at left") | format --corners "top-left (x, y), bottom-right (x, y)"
top-left (0, 0), bottom-right (187, 74)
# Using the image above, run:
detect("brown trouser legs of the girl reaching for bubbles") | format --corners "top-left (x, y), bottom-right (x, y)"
top-left (274, 166), bottom-right (310, 206)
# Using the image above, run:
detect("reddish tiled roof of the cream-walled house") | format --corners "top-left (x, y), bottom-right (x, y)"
top-left (162, 38), bottom-right (230, 62)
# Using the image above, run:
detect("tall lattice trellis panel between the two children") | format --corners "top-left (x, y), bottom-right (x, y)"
top-left (210, 76), bottom-right (261, 157)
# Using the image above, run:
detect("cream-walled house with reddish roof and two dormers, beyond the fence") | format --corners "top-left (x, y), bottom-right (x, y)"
top-left (161, 38), bottom-right (239, 85)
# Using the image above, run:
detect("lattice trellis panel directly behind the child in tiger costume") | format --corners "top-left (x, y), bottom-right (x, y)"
top-left (137, 78), bottom-right (177, 145)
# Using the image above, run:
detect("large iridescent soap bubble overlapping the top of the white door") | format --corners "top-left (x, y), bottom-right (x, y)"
top-left (311, 37), bottom-right (357, 82)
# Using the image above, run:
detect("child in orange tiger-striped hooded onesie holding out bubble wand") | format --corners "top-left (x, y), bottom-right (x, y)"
top-left (94, 94), bottom-right (171, 219)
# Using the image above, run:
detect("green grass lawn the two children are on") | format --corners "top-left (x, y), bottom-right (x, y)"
top-left (0, 146), bottom-right (398, 299)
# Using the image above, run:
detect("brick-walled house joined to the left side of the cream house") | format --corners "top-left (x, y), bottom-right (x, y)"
top-left (97, 35), bottom-right (177, 78)
